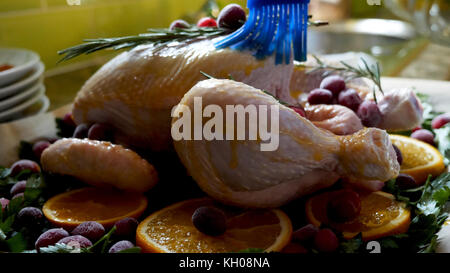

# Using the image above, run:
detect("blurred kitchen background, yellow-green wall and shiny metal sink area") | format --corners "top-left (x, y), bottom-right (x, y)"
top-left (0, 0), bottom-right (450, 115)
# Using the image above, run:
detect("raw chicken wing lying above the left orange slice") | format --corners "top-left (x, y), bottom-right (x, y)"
top-left (41, 138), bottom-right (158, 192)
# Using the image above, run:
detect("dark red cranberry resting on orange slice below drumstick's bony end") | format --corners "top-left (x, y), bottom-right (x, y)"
top-left (327, 189), bottom-right (361, 223)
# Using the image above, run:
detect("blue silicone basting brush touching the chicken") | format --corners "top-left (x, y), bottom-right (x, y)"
top-left (215, 0), bottom-right (309, 64)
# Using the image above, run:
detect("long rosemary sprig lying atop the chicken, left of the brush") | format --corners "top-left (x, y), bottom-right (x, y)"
top-left (58, 27), bottom-right (233, 62)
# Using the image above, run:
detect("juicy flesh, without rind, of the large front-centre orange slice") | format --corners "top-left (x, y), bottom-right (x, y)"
top-left (139, 200), bottom-right (281, 253)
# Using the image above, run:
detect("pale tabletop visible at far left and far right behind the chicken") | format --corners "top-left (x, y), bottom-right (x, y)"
top-left (0, 78), bottom-right (450, 166)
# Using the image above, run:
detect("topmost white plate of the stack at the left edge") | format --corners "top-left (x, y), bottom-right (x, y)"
top-left (0, 48), bottom-right (40, 86)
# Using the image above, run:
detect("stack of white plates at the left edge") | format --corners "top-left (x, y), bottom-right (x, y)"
top-left (0, 48), bottom-right (50, 123)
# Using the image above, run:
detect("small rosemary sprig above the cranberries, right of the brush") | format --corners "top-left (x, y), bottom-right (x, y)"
top-left (298, 55), bottom-right (384, 102)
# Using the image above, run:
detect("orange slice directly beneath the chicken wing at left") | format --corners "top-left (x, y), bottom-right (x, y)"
top-left (42, 188), bottom-right (147, 230)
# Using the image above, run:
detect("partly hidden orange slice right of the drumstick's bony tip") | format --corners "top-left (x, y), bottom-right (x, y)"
top-left (390, 135), bottom-right (445, 185)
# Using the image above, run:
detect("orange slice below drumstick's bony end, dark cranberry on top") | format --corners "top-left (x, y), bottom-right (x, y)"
top-left (306, 189), bottom-right (411, 241)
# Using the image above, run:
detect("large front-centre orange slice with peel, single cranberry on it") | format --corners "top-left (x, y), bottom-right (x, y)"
top-left (136, 198), bottom-right (292, 253)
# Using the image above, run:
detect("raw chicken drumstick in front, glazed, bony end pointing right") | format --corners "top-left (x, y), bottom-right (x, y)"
top-left (173, 80), bottom-right (400, 208)
